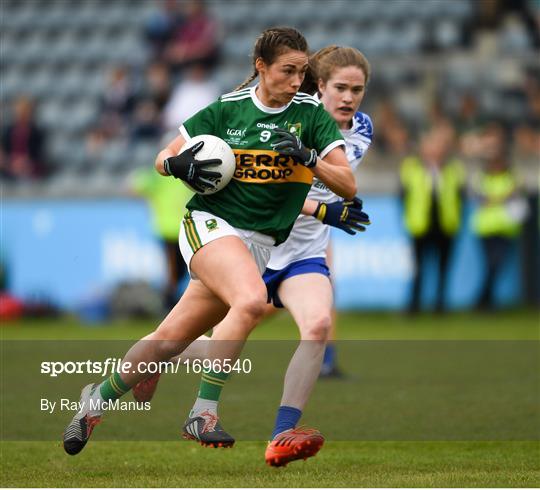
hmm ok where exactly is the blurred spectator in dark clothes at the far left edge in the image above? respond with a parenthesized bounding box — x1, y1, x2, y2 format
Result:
(0, 96, 49, 180)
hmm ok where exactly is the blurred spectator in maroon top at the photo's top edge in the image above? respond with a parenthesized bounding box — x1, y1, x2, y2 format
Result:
(163, 0, 219, 72)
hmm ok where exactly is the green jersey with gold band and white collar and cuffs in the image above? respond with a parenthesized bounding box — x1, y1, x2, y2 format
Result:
(180, 87, 345, 245)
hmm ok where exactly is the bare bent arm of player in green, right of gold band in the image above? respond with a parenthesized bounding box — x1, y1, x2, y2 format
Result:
(313, 147, 356, 199)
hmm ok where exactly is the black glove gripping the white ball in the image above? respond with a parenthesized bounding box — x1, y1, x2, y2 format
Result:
(163, 141, 221, 192)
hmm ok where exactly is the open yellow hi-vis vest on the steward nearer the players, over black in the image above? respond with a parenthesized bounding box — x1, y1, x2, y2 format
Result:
(401, 157, 465, 237)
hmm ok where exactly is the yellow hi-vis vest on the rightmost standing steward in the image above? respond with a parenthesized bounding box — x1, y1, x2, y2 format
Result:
(472, 170, 521, 238)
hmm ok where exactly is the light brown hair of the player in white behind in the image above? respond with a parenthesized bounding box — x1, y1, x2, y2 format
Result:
(300, 45, 371, 94)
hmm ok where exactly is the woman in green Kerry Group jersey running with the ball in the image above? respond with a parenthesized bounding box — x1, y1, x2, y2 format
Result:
(64, 28, 356, 454)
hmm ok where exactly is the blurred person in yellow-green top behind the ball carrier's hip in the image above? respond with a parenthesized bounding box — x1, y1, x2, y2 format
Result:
(132, 168, 193, 310)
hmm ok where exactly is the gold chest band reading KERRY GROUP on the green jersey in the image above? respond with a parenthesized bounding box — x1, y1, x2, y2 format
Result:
(233, 150, 313, 184)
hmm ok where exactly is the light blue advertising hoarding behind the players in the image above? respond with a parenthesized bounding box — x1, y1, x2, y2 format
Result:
(2, 195, 521, 310)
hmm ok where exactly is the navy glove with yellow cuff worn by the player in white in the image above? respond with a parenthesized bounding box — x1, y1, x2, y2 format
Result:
(313, 197, 371, 235)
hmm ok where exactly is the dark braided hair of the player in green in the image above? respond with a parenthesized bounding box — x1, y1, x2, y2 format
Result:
(234, 27, 308, 91)
